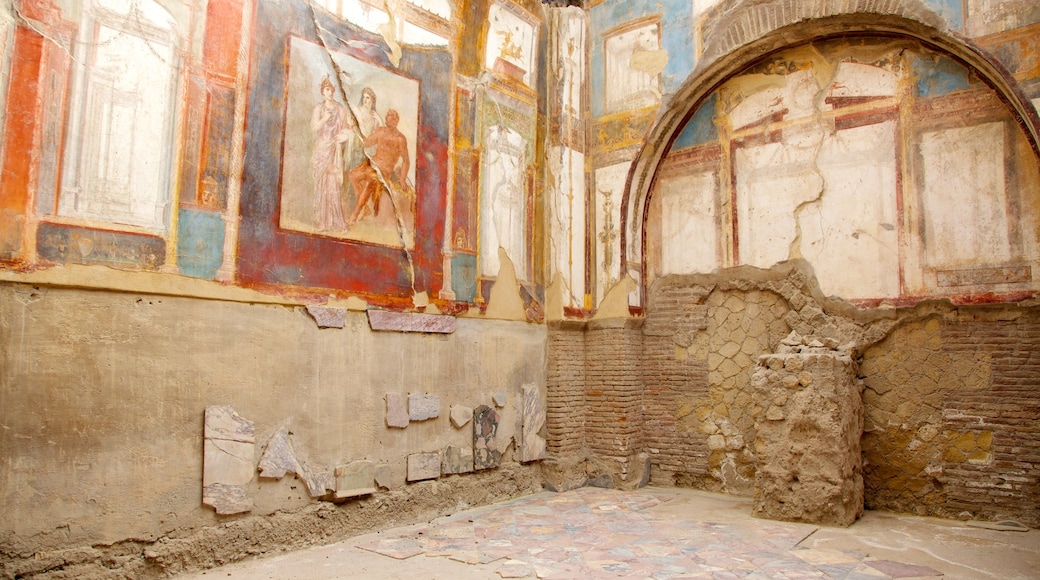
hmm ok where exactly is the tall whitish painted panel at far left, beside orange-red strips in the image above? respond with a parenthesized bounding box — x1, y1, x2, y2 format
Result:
(58, 2, 178, 230)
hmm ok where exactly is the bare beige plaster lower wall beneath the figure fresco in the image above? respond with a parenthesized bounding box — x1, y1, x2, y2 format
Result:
(0, 284, 546, 577)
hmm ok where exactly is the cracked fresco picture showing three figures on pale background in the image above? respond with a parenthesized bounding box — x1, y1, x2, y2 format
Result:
(280, 37, 419, 247)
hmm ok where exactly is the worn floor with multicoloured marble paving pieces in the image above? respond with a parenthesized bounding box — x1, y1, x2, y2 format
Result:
(179, 487, 1040, 580)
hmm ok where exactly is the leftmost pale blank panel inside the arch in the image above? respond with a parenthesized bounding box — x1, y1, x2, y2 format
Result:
(656, 170, 720, 275)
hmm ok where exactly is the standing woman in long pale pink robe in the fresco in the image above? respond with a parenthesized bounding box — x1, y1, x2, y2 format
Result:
(311, 77, 354, 232)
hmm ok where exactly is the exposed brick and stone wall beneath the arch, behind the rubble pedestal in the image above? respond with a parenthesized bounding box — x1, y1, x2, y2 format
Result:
(632, 266, 1040, 526)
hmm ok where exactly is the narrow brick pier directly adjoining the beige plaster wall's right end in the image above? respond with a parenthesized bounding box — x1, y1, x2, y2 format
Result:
(545, 324, 586, 457)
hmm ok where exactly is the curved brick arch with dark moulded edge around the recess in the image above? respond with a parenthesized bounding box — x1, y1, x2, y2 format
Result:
(620, 6, 1040, 306)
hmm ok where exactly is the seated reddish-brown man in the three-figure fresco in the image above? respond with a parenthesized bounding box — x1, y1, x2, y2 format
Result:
(346, 109, 411, 226)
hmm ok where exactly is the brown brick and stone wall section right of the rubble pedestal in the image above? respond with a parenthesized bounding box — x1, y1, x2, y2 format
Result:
(860, 307, 1040, 527)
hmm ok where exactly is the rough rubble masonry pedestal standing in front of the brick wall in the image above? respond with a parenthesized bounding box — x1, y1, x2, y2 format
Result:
(752, 351, 863, 526)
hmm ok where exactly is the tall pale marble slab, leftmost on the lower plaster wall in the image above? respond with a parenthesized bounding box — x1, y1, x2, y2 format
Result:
(202, 405, 256, 515)
